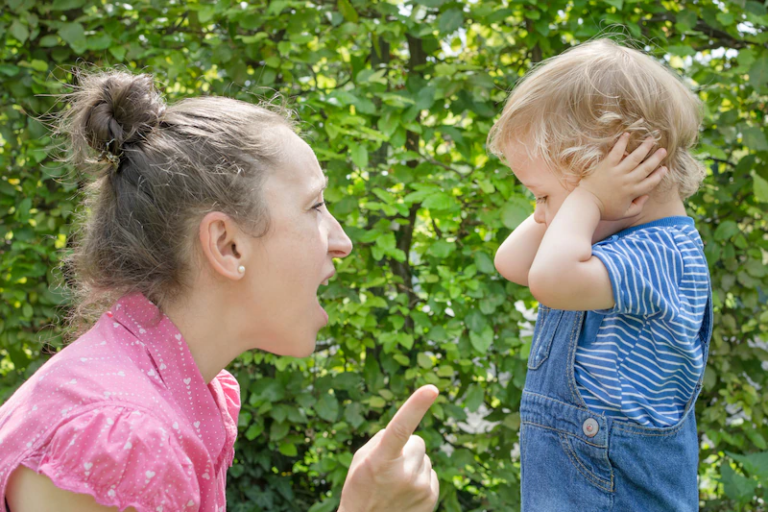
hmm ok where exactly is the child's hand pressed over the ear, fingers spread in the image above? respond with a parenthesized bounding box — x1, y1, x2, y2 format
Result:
(578, 133, 667, 220)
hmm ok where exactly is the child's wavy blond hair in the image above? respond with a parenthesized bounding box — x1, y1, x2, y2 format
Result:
(488, 39, 706, 199)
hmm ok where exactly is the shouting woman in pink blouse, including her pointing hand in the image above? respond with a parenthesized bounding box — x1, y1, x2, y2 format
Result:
(0, 72, 439, 512)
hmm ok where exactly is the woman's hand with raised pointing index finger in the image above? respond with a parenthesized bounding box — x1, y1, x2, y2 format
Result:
(339, 385, 440, 512)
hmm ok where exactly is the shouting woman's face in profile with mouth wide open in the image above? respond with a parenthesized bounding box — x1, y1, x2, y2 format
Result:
(242, 128, 352, 357)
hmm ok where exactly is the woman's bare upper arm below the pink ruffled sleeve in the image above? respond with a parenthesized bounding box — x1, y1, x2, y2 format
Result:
(6, 465, 136, 512)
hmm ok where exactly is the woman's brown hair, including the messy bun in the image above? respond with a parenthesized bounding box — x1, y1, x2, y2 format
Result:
(57, 71, 293, 330)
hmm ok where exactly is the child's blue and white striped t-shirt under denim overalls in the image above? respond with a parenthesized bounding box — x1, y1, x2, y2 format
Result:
(574, 216, 712, 427)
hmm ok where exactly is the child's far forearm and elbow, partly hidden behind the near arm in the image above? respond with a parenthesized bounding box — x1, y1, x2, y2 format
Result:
(493, 211, 547, 286)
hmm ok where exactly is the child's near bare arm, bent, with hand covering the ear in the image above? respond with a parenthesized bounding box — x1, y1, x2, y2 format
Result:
(528, 134, 666, 311)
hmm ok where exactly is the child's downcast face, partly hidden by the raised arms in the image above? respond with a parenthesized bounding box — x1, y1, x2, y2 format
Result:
(503, 143, 578, 226)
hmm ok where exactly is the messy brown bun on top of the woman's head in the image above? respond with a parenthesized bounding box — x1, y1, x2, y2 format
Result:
(60, 70, 165, 171)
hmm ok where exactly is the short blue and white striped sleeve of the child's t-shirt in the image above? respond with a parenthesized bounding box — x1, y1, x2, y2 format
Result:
(592, 231, 686, 320)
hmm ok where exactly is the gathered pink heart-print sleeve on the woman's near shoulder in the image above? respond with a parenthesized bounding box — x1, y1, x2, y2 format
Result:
(24, 407, 200, 512)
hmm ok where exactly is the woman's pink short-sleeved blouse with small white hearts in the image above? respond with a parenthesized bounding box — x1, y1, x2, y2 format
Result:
(0, 294, 240, 512)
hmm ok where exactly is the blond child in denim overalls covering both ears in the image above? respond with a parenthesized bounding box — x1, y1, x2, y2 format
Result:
(489, 40, 712, 512)
